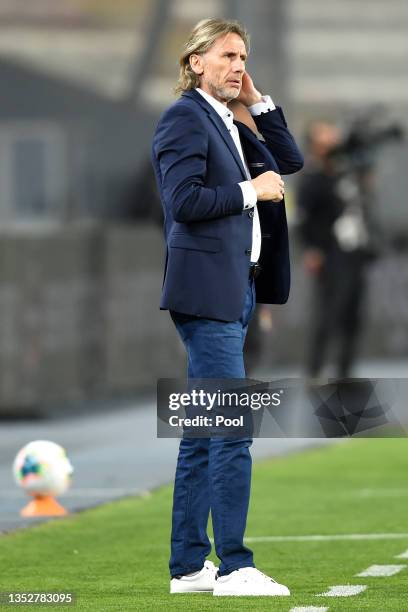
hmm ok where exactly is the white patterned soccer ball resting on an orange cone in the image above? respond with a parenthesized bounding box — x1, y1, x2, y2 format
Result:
(13, 440, 74, 497)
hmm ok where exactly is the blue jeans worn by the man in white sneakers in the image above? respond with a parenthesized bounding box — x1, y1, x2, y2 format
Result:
(169, 280, 255, 577)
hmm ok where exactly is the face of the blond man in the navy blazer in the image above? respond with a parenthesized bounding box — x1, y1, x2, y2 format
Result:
(190, 32, 247, 104)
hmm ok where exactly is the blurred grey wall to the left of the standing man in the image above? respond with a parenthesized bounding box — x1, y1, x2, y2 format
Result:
(0, 224, 184, 415)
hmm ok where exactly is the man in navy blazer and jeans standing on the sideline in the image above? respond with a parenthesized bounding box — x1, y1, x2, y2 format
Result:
(152, 19, 303, 595)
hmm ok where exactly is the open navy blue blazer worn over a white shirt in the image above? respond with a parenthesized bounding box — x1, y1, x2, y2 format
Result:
(152, 90, 303, 321)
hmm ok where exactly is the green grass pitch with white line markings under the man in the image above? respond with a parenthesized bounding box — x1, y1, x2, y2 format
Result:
(0, 439, 408, 612)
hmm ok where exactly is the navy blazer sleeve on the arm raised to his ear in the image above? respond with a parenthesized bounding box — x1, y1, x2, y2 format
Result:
(253, 106, 304, 174)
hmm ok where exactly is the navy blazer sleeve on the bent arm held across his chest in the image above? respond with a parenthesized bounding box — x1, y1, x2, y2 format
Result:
(152, 104, 243, 223)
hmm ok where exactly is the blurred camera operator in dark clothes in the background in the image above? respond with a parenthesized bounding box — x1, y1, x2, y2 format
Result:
(296, 121, 378, 378)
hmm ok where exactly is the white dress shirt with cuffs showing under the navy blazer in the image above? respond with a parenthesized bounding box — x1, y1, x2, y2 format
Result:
(196, 87, 276, 263)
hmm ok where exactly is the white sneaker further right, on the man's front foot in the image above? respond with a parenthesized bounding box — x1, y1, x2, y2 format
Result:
(213, 567, 290, 597)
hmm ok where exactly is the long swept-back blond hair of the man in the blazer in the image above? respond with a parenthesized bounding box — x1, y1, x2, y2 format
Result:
(174, 19, 249, 93)
